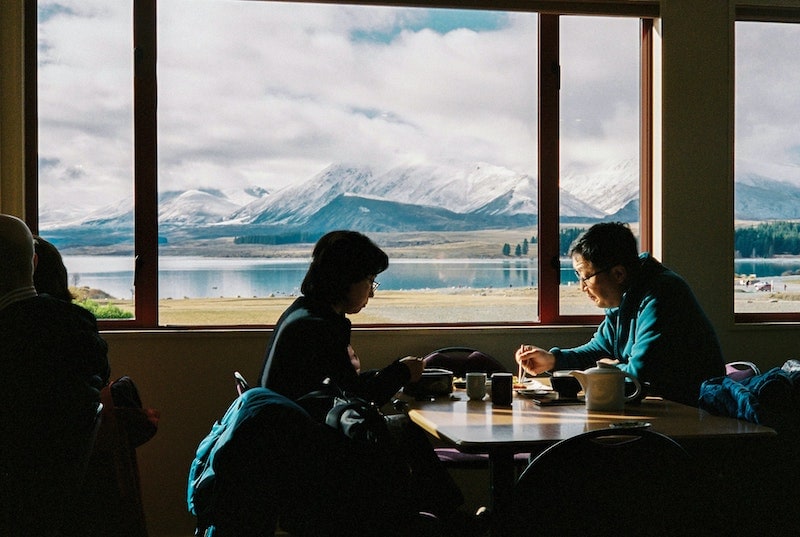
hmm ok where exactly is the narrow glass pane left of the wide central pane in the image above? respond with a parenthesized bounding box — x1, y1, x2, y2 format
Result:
(37, 0, 134, 318)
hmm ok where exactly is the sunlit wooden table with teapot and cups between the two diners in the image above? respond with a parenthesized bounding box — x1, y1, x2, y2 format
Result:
(408, 390, 776, 537)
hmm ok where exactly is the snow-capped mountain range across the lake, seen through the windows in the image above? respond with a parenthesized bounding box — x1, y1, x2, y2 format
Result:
(40, 160, 800, 246)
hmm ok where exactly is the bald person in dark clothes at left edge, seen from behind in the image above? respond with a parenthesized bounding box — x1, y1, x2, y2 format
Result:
(0, 211, 110, 536)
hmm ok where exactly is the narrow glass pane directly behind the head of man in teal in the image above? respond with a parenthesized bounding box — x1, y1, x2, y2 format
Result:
(559, 17, 641, 315)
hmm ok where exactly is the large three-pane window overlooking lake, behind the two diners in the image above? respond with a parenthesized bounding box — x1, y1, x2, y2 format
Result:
(38, 0, 646, 326)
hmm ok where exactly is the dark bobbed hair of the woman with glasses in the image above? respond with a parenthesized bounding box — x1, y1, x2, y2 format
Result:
(300, 230, 389, 304)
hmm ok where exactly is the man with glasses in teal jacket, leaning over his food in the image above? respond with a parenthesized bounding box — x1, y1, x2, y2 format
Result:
(516, 223, 725, 406)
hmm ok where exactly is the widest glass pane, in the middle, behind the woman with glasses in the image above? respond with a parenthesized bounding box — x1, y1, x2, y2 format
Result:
(158, 0, 538, 325)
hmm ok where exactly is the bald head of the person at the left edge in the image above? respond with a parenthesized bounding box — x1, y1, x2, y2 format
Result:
(0, 214, 34, 295)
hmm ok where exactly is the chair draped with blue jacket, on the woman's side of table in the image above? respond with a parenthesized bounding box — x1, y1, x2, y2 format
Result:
(187, 387, 436, 537)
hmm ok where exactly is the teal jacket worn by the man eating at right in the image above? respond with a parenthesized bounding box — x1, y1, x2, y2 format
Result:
(550, 253, 725, 406)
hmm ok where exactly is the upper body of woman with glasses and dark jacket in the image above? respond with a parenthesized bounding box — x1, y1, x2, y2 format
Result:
(261, 231, 424, 405)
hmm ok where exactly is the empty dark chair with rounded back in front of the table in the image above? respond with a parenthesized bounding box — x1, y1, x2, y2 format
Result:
(513, 428, 696, 536)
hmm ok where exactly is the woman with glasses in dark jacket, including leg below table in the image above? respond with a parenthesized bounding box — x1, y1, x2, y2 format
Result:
(260, 231, 476, 535)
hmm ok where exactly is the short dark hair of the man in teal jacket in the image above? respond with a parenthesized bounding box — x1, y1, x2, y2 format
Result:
(569, 222, 639, 270)
